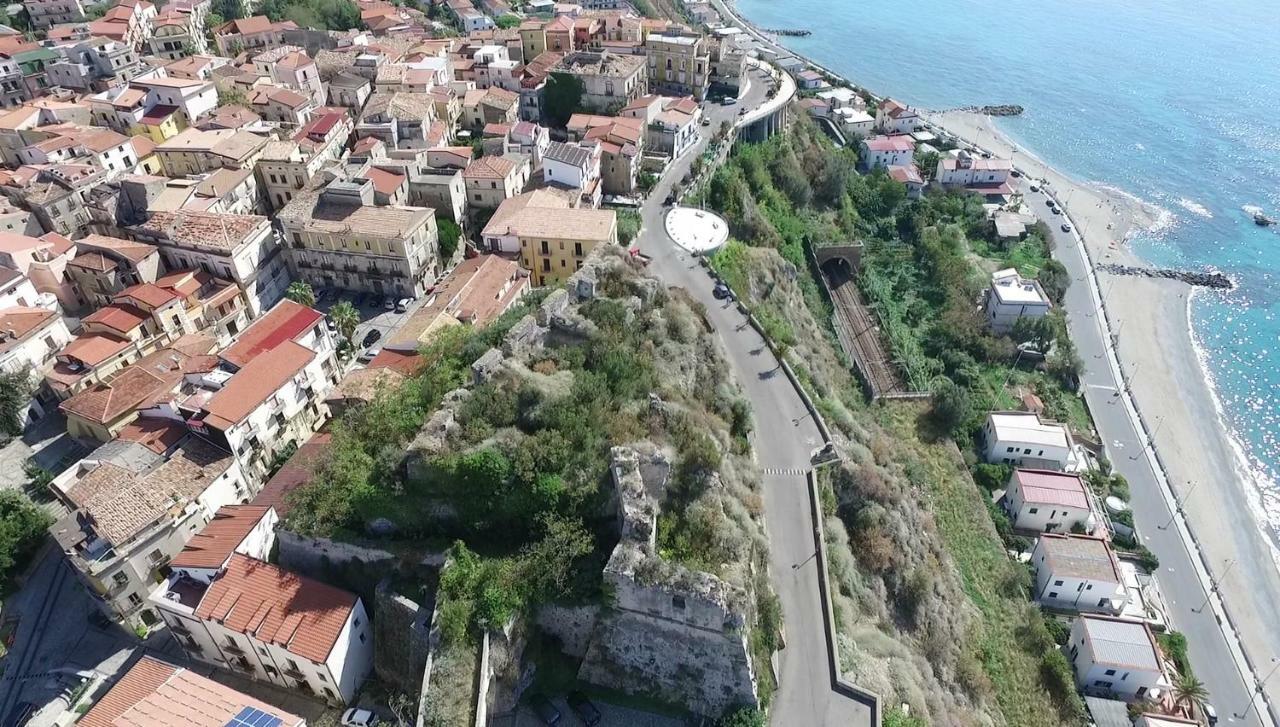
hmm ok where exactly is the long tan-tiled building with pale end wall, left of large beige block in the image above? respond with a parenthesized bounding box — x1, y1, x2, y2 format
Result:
(129, 210, 289, 314)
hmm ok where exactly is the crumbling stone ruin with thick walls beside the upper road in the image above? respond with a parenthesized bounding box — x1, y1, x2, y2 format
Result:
(579, 447, 758, 717)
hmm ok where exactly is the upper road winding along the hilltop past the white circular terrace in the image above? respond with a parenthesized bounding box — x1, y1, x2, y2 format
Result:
(637, 69, 872, 727)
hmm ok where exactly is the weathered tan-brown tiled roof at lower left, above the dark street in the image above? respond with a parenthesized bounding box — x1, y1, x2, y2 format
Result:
(67, 436, 232, 544)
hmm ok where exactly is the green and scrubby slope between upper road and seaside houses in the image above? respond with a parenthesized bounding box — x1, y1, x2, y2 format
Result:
(703, 119, 1083, 727)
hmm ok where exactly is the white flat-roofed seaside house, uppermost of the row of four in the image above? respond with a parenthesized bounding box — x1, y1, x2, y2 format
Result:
(982, 411, 1084, 472)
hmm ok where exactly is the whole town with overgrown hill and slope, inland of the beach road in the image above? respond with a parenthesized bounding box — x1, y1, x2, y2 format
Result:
(0, 0, 1228, 727)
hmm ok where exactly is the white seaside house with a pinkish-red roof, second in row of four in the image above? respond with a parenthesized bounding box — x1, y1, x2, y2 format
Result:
(1005, 470, 1097, 532)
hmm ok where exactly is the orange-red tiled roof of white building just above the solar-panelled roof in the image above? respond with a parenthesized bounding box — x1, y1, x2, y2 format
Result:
(196, 553, 358, 664)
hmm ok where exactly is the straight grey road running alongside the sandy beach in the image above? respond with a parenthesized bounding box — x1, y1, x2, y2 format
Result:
(1034, 179, 1271, 727)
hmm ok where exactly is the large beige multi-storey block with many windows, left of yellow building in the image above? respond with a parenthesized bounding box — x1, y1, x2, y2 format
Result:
(279, 183, 440, 297)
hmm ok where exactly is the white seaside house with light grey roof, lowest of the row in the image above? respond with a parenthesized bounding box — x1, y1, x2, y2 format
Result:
(1068, 616, 1169, 699)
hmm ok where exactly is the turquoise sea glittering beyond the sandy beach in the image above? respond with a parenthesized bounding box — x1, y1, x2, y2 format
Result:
(737, 0, 1280, 504)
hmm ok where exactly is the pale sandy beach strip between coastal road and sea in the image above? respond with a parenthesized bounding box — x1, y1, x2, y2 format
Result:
(713, 0, 1280, 712)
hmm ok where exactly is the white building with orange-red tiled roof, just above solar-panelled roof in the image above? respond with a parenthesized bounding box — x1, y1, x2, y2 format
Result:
(151, 552, 374, 704)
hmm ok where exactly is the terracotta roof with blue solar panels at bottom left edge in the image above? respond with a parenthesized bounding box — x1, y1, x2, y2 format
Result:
(78, 657, 305, 727)
